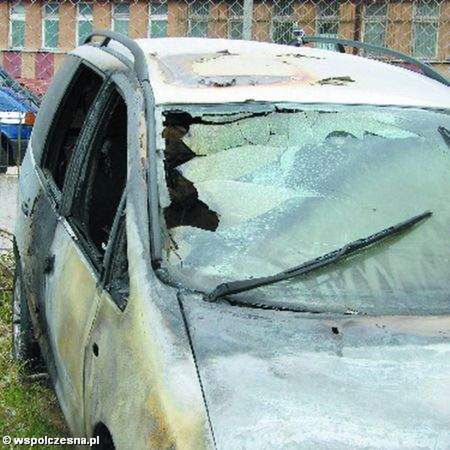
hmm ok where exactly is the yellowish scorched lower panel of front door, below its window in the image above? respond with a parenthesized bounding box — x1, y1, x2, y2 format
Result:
(44, 225, 97, 435)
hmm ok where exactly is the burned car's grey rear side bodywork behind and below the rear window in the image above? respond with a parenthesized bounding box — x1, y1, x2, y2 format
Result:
(15, 56, 80, 352)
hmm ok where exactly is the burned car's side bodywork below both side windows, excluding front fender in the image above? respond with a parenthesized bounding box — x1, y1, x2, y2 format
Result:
(16, 144, 96, 435)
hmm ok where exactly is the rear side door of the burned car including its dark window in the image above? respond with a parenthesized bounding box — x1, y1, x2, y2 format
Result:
(16, 56, 107, 379)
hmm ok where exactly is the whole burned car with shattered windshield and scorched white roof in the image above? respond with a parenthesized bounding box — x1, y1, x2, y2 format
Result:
(14, 32, 450, 450)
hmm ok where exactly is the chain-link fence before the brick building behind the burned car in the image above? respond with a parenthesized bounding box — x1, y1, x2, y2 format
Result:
(0, 0, 450, 96)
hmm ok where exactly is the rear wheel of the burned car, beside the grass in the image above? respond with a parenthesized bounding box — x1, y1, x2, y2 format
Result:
(12, 269, 40, 370)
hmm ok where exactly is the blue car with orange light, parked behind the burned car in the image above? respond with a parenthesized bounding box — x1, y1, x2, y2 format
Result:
(0, 68, 39, 173)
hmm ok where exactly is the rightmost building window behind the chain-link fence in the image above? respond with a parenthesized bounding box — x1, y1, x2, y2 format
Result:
(413, 0, 440, 59)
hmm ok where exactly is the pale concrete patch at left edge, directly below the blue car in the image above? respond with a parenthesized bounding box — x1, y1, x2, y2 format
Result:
(0, 174, 18, 251)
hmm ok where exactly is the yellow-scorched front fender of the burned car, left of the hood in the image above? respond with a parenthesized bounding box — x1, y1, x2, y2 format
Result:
(85, 229, 214, 450)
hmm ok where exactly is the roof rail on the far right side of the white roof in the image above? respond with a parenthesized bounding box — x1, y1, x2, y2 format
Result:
(290, 30, 450, 86)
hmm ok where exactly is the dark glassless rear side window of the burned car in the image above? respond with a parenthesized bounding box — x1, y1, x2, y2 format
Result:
(43, 64, 103, 190)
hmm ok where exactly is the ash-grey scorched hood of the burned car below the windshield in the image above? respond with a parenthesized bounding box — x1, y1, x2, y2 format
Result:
(181, 296, 450, 449)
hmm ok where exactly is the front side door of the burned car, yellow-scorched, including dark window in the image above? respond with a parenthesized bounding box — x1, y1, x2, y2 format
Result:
(45, 77, 132, 434)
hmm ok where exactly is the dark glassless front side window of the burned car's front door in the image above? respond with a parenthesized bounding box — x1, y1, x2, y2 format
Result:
(69, 88, 127, 268)
